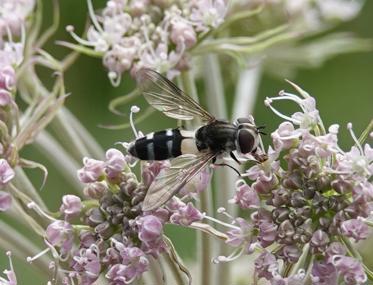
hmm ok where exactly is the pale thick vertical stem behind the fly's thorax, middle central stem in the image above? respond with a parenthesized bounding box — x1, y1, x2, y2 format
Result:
(203, 55, 231, 285)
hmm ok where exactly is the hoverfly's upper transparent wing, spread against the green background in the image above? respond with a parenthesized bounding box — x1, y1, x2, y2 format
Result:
(136, 68, 215, 122)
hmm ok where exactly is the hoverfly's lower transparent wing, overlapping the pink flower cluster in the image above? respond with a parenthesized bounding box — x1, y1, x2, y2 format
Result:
(142, 153, 215, 211)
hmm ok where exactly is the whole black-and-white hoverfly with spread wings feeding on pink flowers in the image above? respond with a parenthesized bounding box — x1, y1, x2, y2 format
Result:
(128, 68, 266, 211)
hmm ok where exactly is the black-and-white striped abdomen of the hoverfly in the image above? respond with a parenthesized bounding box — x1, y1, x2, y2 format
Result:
(128, 129, 198, 160)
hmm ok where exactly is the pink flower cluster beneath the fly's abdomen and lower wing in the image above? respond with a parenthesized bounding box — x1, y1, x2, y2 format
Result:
(29, 149, 203, 284)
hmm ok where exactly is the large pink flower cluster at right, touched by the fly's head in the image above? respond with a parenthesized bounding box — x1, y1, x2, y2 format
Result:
(227, 86, 373, 285)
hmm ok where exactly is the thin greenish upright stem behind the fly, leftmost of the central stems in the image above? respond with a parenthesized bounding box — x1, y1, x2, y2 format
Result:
(181, 72, 215, 285)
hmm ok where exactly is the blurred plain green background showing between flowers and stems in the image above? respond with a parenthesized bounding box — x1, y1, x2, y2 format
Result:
(0, 0, 373, 285)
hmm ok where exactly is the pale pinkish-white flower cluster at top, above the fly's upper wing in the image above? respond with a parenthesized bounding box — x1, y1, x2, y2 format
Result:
(67, 0, 227, 84)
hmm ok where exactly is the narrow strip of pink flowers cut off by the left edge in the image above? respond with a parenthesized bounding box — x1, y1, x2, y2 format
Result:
(0, 0, 35, 211)
